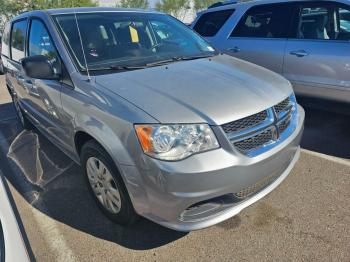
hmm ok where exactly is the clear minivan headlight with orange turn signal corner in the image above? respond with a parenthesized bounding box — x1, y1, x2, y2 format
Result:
(135, 124, 219, 161)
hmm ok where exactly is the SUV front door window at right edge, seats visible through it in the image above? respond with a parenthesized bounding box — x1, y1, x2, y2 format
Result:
(296, 3, 350, 40)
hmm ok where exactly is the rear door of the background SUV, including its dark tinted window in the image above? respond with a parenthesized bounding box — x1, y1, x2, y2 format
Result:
(221, 3, 293, 74)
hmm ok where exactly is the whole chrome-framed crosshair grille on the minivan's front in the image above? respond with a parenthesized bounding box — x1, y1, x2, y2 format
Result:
(222, 95, 297, 157)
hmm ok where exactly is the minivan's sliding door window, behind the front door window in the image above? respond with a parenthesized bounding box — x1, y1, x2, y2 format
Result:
(11, 20, 28, 62)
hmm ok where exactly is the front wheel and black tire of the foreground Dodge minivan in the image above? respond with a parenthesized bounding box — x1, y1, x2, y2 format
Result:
(80, 140, 138, 225)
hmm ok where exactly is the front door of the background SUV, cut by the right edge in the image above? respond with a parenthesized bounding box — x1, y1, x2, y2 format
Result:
(283, 1, 350, 102)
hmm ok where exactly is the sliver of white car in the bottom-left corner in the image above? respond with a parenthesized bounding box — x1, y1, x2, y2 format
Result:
(0, 171, 30, 262)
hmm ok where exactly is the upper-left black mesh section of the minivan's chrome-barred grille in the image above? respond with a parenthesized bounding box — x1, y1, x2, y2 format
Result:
(222, 110, 267, 134)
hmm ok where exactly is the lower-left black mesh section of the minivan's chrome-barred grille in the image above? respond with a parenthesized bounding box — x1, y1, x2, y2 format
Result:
(234, 129, 274, 154)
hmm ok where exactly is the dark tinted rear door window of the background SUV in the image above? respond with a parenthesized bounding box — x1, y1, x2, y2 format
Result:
(231, 4, 293, 38)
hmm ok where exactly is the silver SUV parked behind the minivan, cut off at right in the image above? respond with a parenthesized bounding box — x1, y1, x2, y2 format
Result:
(192, 0, 350, 102)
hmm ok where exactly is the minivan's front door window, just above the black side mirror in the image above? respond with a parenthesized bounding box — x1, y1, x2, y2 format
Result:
(28, 19, 60, 73)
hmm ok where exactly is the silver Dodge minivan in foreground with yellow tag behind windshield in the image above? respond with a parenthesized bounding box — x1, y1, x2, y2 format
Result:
(2, 8, 304, 231)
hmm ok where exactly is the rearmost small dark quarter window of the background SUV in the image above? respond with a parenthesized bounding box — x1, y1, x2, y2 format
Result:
(193, 9, 234, 37)
